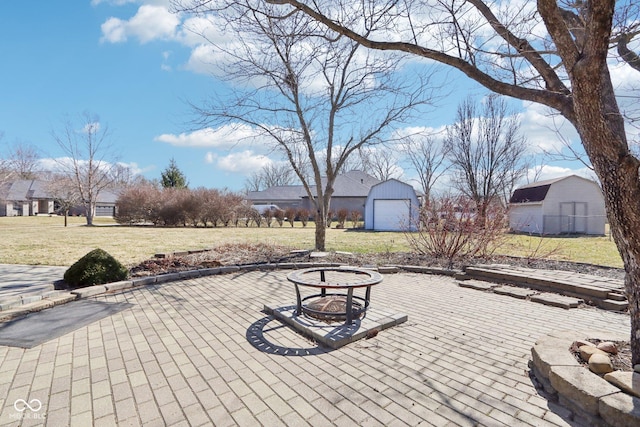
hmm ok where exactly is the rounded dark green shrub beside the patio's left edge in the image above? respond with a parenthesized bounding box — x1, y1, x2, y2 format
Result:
(64, 249, 129, 288)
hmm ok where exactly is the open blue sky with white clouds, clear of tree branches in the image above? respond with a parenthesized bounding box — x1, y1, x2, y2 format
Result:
(0, 0, 637, 190)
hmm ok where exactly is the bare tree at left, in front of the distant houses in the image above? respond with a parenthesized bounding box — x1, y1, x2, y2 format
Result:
(52, 113, 116, 225)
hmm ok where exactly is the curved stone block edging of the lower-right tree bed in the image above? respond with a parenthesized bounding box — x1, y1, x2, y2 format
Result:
(530, 331, 640, 427)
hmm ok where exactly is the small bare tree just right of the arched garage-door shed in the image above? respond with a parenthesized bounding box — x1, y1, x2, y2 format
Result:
(402, 133, 450, 204)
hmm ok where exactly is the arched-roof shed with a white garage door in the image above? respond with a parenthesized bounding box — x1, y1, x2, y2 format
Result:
(364, 179, 420, 231)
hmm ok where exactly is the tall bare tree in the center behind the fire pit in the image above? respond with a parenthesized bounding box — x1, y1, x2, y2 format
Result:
(176, 0, 436, 250)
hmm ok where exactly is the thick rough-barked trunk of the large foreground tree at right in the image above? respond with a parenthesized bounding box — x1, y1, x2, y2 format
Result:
(572, 62, 640, 365)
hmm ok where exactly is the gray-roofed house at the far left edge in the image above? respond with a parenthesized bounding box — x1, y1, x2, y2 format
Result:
(0, 179, 54, 216)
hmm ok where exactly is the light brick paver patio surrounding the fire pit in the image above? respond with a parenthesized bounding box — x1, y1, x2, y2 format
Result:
(0, 271, 630, 426)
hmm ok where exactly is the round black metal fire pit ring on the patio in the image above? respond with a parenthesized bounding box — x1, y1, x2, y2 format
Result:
(287, 267, 382, 325)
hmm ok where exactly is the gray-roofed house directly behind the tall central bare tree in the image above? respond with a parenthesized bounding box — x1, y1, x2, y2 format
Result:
(247, 170, 380, 216)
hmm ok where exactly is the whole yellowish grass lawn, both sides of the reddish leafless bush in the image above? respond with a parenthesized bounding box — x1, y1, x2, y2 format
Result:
(0, 216, 622, 267)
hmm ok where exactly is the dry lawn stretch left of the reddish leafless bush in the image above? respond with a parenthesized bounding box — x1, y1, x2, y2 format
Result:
(0, 216, 408, 266)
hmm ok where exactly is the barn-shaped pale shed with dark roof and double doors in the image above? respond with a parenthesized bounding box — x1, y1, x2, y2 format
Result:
(509, 175, 606, 235)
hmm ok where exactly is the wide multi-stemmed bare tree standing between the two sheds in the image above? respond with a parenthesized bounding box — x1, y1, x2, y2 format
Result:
(445, 95, 527, 218)
